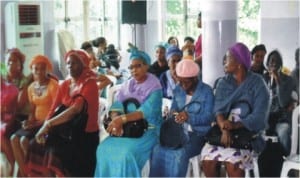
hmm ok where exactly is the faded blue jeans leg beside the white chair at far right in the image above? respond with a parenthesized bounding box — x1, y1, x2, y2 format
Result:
(275, 122, 292, 155)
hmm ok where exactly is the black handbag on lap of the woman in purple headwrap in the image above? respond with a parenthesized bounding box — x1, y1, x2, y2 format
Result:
(205, 100, 258, 150)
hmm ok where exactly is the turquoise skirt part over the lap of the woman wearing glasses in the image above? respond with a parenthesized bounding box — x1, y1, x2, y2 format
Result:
(95, 131, 158, 176)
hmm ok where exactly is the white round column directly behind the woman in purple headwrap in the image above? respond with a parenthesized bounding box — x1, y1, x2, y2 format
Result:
(202, 1, 237, 86)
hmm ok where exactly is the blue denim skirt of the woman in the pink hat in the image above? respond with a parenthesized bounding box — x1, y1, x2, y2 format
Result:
(149, 132, 204, 177)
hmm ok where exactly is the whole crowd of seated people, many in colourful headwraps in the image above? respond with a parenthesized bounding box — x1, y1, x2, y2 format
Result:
(1, 33, 299, 177)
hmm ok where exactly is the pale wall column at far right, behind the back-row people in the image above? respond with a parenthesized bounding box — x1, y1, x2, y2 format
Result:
(259, 0, 300, 70)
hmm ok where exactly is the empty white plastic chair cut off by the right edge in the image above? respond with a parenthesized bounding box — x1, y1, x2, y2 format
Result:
(280, 105, 300, 177)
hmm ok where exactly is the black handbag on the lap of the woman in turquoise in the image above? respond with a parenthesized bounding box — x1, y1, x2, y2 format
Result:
(103, 98, 148, 138)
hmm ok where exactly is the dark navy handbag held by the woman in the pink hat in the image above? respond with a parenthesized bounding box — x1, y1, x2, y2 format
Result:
(159, 101, 200, 149)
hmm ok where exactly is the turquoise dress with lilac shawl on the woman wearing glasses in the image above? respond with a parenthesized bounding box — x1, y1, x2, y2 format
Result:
(95, 74, 162, 177)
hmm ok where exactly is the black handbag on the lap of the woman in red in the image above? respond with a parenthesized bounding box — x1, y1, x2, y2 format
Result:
(47, 95, 88, 142)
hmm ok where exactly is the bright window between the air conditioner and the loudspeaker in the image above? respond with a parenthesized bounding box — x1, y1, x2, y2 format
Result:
(55, 0, 120, 47)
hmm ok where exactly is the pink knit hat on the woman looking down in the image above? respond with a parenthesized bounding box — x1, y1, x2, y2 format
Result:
(176, 60, 200, 78)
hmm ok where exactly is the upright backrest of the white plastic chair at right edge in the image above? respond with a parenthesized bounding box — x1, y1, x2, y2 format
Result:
(290, 105, 300, 155)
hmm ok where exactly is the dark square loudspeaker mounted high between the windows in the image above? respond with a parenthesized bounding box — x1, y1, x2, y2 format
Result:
(122, 0, 147, 24)
